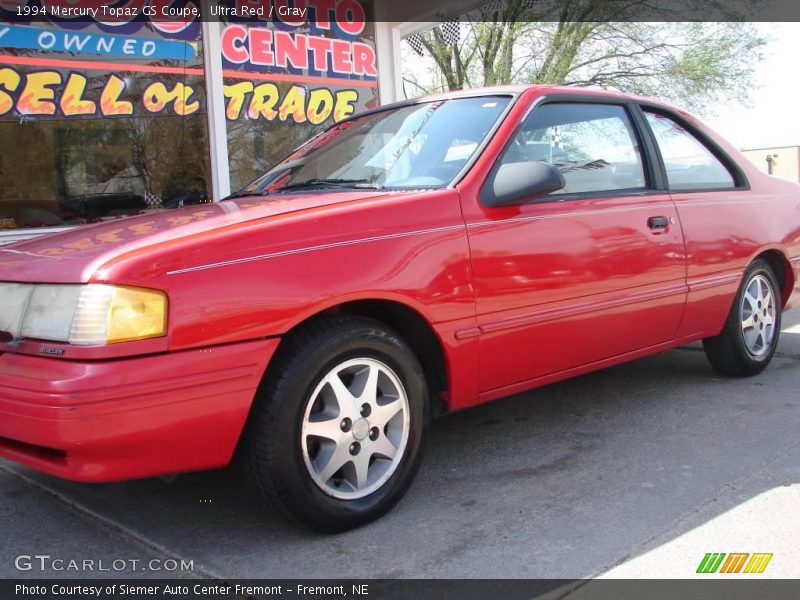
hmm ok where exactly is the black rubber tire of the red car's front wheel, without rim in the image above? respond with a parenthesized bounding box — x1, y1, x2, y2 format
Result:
(240, 315, 428, 533)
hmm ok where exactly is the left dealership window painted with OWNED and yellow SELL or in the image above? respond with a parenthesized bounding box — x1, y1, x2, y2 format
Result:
(0, 15, 210, 230)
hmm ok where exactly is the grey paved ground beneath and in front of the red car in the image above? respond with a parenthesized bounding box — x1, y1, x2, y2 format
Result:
(0, 311, 800, 578)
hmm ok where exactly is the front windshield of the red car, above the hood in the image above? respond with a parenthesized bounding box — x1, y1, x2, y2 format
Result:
(236, 96, 511, 195)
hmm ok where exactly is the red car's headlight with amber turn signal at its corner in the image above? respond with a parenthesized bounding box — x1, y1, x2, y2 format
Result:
(0, 283, 167, 346)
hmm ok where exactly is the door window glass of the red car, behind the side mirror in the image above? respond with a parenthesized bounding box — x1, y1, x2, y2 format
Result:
(502, 102, 647, 195)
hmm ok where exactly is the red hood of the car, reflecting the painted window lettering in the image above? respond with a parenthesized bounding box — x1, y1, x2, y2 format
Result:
(0, 191, 389, 283)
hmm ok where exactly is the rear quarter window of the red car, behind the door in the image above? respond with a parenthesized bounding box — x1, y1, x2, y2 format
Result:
(645, 112, 736, 190)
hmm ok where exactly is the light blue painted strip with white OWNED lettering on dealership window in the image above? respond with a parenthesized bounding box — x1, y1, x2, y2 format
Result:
(0, 25, 195, 60)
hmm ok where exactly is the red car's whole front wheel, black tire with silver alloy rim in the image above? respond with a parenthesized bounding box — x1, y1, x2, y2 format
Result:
(241, 316, 428, 532)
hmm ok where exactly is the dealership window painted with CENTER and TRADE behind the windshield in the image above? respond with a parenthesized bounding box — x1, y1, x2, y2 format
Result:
(220, 9, 378, 191)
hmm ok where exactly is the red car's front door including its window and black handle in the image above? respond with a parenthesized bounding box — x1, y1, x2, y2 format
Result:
(462, 96, 686, 394)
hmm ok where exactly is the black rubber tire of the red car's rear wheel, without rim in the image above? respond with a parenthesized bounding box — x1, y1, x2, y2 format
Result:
(703, 258, 783, 377)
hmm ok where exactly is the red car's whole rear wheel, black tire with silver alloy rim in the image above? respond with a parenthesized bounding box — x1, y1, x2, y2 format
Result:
(703, 259, 782, 376)
